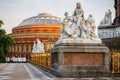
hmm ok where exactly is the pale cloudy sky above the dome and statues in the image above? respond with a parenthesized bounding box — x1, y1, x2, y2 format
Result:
(0, 0, 115, 33)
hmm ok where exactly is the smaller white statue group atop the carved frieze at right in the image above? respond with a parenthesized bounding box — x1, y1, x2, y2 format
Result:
(99, 9, 112, 26)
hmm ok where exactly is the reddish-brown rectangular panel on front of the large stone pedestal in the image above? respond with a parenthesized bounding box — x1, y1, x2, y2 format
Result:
(64, 53, 103, 65)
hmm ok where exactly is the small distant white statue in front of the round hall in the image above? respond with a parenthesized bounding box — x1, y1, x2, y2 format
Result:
(32, 39, 45, 53)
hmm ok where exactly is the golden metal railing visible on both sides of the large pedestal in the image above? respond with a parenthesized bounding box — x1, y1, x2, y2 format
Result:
(31, 51, 120, 74)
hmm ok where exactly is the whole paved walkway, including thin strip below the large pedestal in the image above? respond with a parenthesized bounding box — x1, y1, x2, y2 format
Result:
(0, 63, 120, 80)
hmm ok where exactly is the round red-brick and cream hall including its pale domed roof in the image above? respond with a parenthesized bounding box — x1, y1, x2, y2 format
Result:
(6, 13, 61, 60)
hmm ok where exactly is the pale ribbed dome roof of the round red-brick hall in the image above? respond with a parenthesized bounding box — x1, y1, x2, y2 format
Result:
(18, 13, 61, 26)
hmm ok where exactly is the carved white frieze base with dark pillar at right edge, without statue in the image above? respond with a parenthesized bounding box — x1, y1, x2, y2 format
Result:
(98, 0, 120, 50)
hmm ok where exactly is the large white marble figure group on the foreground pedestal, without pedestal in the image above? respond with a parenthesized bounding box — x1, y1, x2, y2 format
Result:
(57, 2, 101, 44)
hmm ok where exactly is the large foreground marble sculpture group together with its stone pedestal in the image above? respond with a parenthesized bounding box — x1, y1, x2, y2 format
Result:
(50, 2, 110, 77)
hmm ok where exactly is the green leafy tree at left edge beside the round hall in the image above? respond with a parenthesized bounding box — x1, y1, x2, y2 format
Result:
(0, 20, 13, 62)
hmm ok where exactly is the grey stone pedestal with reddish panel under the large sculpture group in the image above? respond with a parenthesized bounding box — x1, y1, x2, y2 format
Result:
(50, 43, 110, 77)
